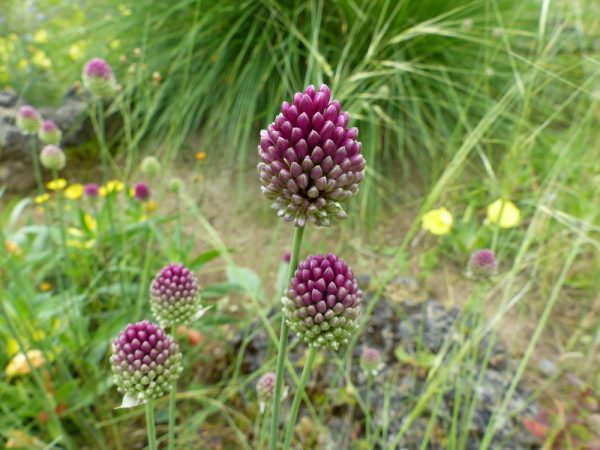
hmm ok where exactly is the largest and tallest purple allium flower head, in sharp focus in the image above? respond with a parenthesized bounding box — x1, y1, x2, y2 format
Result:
(258, 85, 365, 226)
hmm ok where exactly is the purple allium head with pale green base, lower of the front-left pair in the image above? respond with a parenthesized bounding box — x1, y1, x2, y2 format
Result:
(110, 320, 182, 404)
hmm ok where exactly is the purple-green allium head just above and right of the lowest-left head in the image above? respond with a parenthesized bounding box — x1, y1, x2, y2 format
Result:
(150, 263, 202, 326)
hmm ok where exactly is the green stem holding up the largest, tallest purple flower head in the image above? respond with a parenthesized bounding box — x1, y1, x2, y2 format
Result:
(269, 227, 304, 450)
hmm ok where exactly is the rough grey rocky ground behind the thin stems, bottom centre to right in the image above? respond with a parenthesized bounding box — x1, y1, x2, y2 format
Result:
(236, 279, 539, 450)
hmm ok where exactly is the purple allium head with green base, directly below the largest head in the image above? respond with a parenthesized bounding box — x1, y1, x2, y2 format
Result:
(281, 253, 362, 350)
